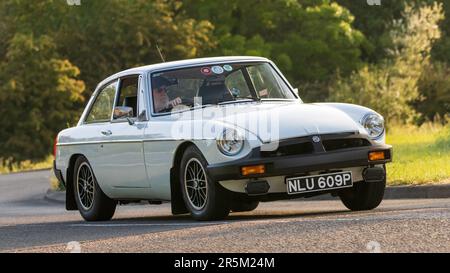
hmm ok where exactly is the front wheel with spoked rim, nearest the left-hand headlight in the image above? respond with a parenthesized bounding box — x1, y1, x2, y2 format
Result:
(179, 146, 230, 221)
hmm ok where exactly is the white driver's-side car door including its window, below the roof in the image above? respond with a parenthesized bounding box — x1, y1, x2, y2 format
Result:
(101, 75, 150, 191)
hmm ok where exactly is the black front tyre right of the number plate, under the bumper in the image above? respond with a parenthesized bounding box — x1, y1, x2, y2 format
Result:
(339, 177, 386, 211)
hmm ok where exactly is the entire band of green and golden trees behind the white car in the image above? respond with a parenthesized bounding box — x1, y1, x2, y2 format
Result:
(0, 0, 450, 162)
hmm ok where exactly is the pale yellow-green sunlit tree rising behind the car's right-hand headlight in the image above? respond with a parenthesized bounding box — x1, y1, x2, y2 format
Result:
(330, 3, 444, 122)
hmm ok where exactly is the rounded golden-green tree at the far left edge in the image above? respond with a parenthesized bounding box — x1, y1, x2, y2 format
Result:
(0, 34, 84, 163)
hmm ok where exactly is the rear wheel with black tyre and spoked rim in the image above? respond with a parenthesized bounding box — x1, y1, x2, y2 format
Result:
(73, 156, 117, 221)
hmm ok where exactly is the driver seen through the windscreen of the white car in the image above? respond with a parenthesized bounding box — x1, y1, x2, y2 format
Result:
(152, 76, 182, 113)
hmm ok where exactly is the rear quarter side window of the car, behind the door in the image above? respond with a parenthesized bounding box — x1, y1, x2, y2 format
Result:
(86, 82, 116, 123)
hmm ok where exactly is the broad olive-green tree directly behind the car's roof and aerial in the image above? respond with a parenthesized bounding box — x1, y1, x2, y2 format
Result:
(55, 0, 213, 93)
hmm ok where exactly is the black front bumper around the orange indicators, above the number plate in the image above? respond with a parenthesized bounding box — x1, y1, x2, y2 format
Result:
(207, 141, 392, 181)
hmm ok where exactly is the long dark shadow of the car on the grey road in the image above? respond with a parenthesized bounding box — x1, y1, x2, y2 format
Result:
(0, 206, 390, 252)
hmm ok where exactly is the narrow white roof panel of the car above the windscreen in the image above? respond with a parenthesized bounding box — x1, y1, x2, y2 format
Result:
(98, 56, 269, 86)
